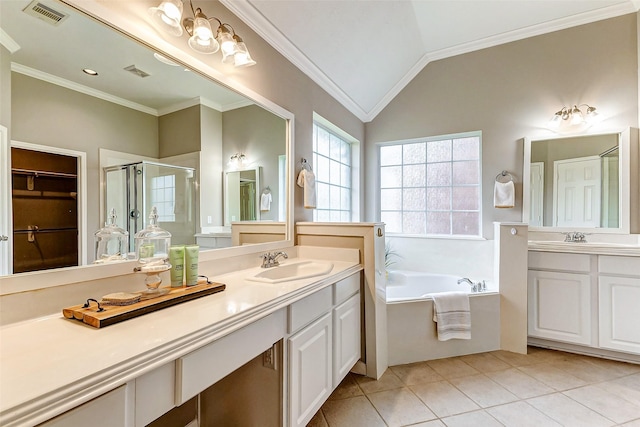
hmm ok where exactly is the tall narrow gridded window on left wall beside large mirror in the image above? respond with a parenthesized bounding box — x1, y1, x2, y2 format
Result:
(313, 116, 353, 222)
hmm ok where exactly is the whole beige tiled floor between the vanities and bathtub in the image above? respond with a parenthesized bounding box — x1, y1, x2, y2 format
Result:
(308, 347, 640, 427)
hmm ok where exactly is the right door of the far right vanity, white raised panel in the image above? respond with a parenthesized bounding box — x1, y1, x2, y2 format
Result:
(598, 276, 640, 354)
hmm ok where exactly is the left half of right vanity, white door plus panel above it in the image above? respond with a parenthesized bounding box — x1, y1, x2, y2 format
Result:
(527, 252, 594, 345)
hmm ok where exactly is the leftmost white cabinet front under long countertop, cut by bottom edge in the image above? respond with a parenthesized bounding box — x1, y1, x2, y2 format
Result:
(40, 385, 127, 427)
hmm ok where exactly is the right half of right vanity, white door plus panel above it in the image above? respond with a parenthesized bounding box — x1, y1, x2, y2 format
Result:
(598, 256, 640, 354)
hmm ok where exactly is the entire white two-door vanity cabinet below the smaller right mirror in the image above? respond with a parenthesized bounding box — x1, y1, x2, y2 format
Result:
(528, 246, 640, 362)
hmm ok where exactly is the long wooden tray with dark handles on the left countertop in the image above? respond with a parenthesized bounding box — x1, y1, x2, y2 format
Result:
(62, 283, 226, 328)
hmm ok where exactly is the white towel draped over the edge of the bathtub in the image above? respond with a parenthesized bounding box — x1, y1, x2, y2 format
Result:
(430, 292, 471, 341)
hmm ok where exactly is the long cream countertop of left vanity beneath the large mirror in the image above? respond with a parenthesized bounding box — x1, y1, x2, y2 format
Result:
(0, 258, 362, 424)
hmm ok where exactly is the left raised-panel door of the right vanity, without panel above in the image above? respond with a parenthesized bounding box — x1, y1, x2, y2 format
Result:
(528, 270, 592, 345)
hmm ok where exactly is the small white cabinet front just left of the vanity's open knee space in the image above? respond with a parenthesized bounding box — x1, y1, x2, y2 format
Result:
(135, 362, 176, 427)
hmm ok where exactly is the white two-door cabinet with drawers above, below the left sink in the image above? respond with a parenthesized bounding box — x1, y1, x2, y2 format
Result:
(287, 273, 361, 426)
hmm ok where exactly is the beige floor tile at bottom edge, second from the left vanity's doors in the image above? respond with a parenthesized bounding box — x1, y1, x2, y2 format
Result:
(367, 388, 437, 427)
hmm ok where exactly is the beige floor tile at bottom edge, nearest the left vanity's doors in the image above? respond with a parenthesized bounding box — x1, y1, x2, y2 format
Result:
(322, 396, 385, 427)
